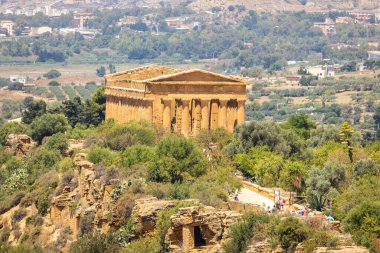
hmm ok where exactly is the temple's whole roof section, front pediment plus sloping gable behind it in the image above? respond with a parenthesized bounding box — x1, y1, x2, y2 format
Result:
(106, 65, 243, 83)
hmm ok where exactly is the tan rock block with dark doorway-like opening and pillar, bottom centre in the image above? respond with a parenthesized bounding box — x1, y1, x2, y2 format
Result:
(166, 206, 242, 252)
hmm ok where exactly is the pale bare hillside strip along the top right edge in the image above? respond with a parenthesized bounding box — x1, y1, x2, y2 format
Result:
(191, 0, 379, 12)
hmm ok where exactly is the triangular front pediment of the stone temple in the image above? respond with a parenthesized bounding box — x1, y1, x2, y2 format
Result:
(145, 69, 242, 83)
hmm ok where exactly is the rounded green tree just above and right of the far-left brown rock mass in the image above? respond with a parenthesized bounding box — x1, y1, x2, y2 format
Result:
(31, 114, 69, 143)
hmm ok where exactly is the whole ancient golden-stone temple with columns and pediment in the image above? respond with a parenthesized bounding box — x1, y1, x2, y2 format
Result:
(105, 65, 246, 136)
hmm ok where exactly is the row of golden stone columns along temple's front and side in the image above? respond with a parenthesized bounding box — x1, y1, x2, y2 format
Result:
(107, 96, 245, 136)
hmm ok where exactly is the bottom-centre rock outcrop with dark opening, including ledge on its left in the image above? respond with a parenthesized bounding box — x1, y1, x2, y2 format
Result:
(132, 197, 242, 252)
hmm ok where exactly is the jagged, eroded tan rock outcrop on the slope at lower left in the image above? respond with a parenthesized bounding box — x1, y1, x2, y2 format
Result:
(50, 153, 118, 236)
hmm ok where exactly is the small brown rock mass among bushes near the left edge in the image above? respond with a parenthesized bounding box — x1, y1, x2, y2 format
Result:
(6, 134, 36, 157)
